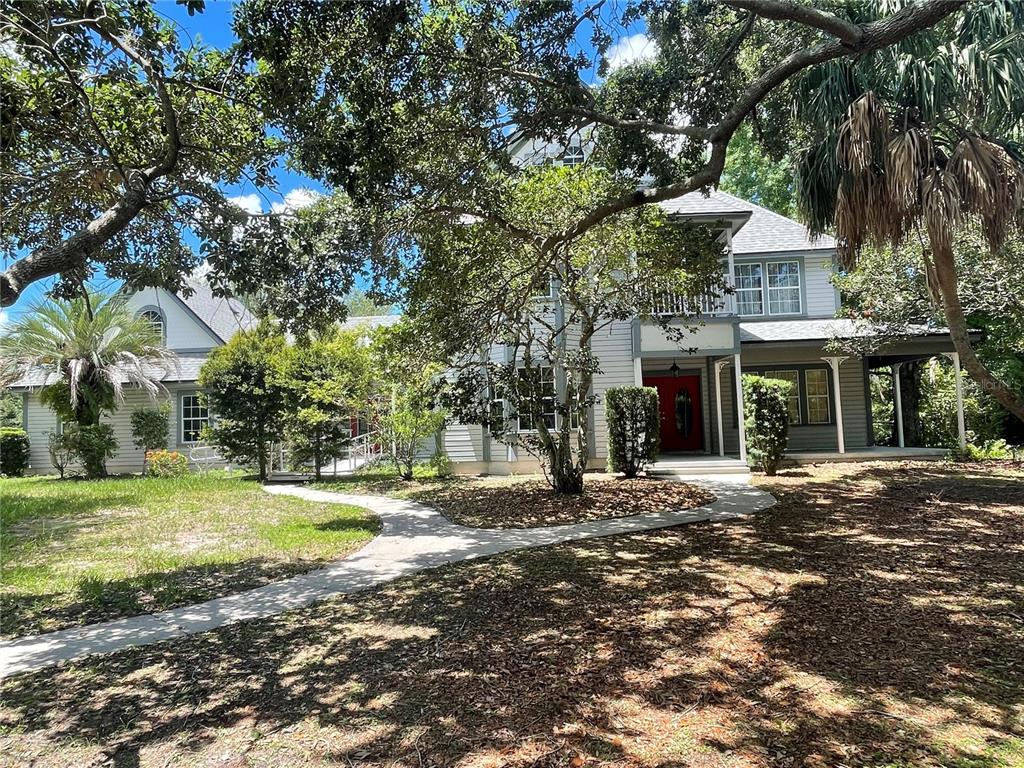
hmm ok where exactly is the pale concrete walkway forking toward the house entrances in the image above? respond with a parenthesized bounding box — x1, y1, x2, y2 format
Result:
(0, 475, 775, 678)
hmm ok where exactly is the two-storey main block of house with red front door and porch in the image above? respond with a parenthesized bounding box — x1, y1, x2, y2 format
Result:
(443, 187, 966, 474)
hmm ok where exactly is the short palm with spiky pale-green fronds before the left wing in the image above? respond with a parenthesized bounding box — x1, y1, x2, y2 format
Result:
(0, 293, 177, 426)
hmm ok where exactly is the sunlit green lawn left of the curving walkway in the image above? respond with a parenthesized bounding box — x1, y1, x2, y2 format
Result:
(0, 473, 378, 637)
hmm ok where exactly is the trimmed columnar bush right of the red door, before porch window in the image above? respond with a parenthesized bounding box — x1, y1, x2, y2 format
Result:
(743, 374, 793, 475)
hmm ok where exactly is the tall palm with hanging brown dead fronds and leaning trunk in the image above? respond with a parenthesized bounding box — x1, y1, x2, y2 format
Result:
(796, 0, 1024, 421)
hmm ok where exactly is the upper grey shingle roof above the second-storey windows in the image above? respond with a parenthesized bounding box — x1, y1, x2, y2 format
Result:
(662, 189, 836, 254)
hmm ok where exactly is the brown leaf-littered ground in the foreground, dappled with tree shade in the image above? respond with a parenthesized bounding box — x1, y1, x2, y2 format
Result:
(0, 464, 1024, 768)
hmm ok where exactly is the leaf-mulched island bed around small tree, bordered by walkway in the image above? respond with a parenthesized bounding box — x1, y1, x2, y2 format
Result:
(412, 475, 715, 528)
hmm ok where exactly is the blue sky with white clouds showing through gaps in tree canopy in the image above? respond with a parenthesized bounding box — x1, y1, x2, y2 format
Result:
(0, 0, 656, 328)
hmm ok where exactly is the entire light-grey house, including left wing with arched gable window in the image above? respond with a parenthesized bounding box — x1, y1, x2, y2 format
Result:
(13, 167, 966, 474)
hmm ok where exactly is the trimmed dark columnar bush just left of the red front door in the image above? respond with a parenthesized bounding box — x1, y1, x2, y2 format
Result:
(604, 387, 662, 477)
